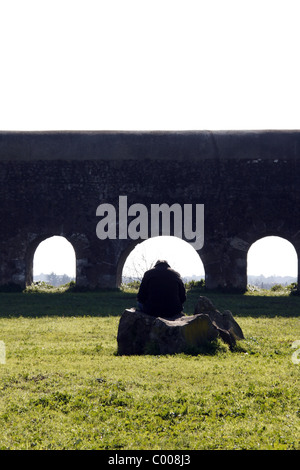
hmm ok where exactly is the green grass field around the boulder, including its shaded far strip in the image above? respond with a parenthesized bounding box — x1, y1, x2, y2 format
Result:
(0, 290, 300, 450)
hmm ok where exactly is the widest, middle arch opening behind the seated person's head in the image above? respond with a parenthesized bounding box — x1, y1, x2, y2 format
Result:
(122, 235, 205, 284)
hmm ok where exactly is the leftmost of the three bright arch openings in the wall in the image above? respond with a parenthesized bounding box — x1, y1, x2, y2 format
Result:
(33, 236, 76, 286)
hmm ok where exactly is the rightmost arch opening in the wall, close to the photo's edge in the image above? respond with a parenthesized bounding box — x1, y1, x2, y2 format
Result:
(247, 236, 298, 289)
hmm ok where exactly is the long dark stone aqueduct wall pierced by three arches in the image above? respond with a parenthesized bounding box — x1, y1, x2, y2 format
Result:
(0, 131, 300, 291)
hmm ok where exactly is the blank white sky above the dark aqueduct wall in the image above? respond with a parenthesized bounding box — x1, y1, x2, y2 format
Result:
(0, 0, 300, 280)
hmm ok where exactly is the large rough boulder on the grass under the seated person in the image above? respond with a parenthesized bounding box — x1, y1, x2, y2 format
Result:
(117, 297, 244, 355)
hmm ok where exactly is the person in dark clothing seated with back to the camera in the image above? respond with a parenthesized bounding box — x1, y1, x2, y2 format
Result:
(137, 260, 186, 318)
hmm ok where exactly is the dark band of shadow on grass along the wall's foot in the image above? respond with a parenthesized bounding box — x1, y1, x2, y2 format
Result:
(0, 289, 300, 318)
